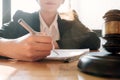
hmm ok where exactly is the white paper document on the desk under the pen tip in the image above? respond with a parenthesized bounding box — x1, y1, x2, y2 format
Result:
(46, 49, 89, 62)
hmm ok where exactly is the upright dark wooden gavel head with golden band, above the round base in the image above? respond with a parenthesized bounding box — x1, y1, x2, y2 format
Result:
(103, 9, 120, 53)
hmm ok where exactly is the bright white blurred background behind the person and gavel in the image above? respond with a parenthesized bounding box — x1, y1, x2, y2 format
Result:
(0, 0, 120, 35)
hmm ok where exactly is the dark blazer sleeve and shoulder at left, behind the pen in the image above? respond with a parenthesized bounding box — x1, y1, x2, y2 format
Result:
(0, 11, 30, 39)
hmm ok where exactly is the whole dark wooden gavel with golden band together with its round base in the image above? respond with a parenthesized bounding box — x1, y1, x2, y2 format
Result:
(78, 9, 120, 78)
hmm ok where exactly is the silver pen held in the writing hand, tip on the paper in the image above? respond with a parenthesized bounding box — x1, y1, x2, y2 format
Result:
(18, 19, 59, 55)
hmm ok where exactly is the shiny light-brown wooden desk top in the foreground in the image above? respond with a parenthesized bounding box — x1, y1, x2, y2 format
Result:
(0, 59, 116, 80)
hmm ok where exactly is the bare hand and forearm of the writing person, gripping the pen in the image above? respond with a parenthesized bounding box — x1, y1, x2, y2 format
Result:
(0, 34, 53, 61)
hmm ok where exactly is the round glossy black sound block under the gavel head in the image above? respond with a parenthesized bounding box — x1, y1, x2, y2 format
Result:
(77, 52, 120, 77)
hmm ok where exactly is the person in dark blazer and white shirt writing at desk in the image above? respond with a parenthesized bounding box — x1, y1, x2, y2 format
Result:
(0, 0, 100, 61)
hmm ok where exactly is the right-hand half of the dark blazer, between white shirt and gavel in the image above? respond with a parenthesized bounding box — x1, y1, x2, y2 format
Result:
(58, 16, 100, 50)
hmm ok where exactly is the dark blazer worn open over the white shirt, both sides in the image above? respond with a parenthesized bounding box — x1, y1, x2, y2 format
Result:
(0, 11, 100, 50)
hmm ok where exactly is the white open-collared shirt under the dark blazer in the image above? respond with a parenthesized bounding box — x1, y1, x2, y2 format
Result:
(39, 13, 60, 41)
